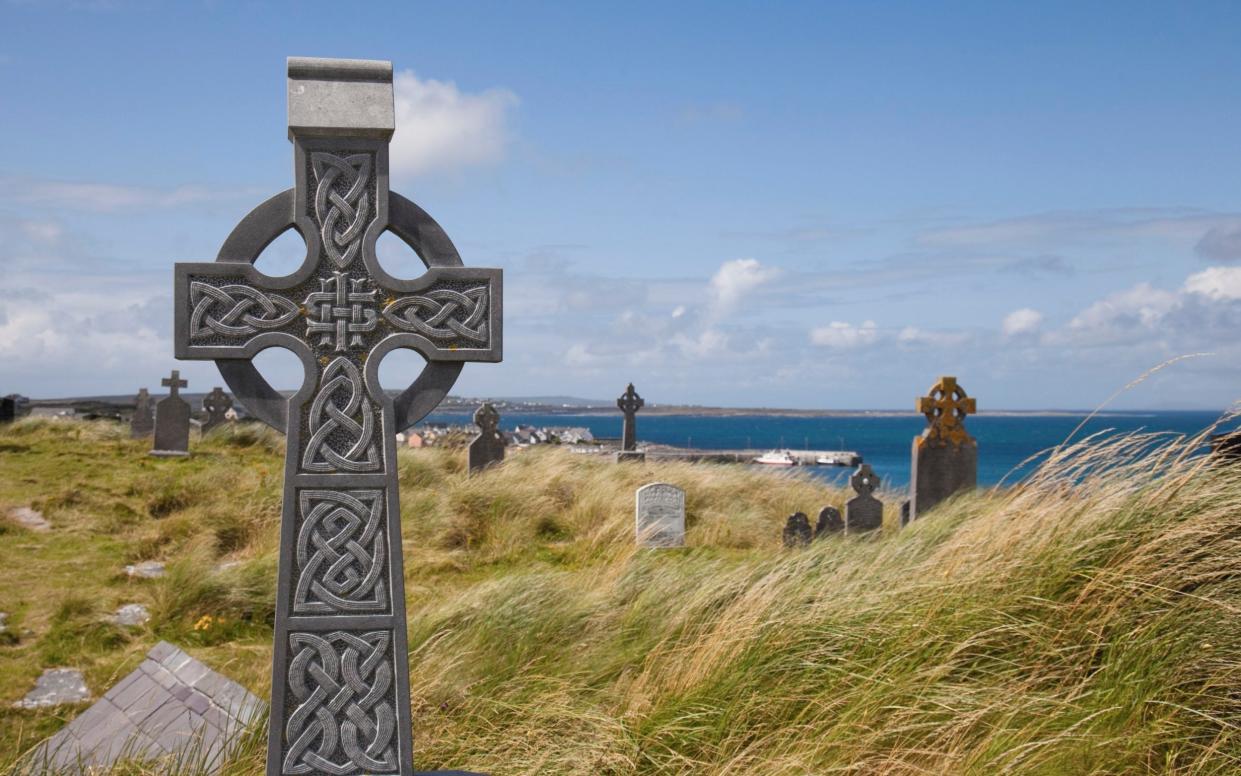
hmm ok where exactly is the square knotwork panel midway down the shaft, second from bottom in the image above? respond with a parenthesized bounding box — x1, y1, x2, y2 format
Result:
(293, 490, 388, 613)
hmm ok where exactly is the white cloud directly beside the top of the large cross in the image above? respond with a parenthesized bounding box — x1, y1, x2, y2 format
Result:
(390, 71, 520, 175)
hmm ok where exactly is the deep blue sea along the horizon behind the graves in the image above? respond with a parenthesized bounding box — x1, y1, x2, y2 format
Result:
(427, 411, 1236, 488)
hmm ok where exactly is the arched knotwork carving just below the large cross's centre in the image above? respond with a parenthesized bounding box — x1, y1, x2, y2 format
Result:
(302, 356, 380, 472)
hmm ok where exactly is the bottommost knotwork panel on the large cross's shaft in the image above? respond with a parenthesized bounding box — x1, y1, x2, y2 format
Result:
(283, 631, 398, 776)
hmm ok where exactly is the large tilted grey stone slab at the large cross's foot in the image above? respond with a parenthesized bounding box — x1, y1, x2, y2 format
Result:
(24, 642, 266, 774)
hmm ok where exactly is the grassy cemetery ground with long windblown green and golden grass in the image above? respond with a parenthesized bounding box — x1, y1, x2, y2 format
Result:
(0, 420, 1241, 776)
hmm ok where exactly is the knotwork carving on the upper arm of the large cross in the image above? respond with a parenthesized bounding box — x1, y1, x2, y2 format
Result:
(310, 151, 371, 269)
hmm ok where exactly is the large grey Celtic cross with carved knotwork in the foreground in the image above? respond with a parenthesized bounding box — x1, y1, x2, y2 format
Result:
(175, 58, 501, 776)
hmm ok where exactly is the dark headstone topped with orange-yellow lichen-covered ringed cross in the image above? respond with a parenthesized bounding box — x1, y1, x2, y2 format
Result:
(910, 376, 978, 520)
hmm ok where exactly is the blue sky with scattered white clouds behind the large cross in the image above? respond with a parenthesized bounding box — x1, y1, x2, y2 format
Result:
(0, 0, 1241, 408)
